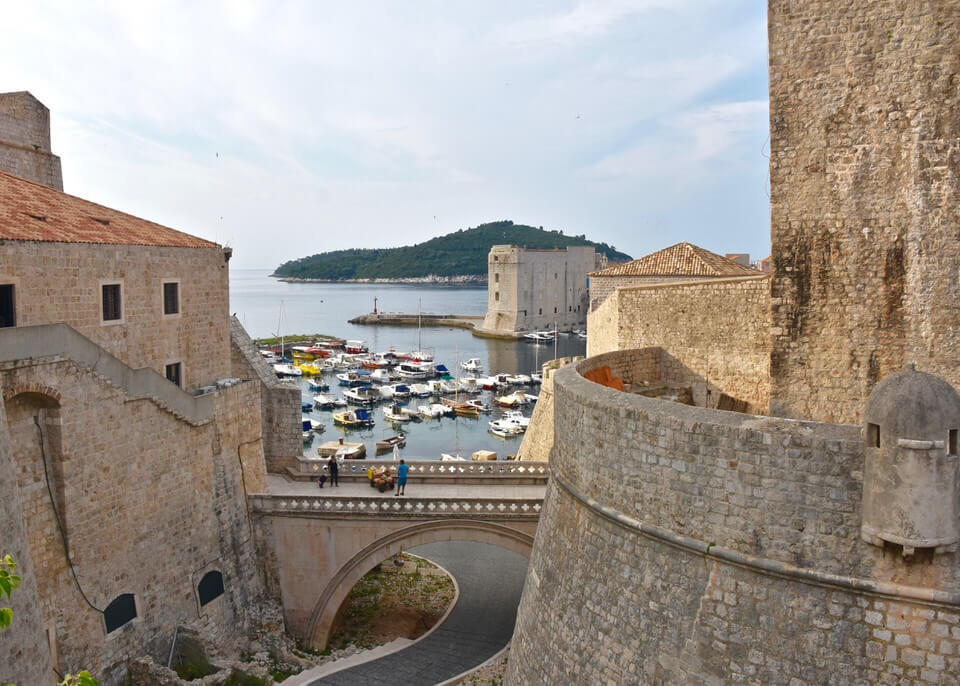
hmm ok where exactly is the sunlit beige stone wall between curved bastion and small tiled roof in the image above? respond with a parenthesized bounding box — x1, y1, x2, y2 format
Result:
(587, 276, 770, 413)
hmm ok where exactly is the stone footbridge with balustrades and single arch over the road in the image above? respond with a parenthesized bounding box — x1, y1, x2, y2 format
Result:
(249, 460, 549, 648)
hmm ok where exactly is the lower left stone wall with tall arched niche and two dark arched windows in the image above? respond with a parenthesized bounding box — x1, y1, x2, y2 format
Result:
(0, 359, 265, 685)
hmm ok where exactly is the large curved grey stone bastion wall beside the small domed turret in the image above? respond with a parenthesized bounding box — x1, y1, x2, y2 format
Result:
(507, 350, 960, 684)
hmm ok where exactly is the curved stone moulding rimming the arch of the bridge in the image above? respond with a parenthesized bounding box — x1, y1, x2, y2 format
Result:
(306, 519, 533, 649)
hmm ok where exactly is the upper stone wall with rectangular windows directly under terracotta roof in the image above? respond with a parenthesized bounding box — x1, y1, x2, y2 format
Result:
(0, 241, 230, 389)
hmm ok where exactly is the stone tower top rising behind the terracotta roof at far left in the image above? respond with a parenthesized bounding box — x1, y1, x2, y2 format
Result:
(0, 91, 63, 191)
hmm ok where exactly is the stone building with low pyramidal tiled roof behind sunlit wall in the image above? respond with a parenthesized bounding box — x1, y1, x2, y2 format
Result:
(588, 241, 757, 319)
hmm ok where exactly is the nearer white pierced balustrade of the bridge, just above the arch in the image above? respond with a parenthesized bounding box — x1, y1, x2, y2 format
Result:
(250, 495, 543, 519)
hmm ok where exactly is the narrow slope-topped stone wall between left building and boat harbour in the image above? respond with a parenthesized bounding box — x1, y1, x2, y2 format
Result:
(230, 317, 303, 472)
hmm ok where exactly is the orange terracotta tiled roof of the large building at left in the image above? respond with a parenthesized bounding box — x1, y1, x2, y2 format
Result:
(0, 172, 219, 248)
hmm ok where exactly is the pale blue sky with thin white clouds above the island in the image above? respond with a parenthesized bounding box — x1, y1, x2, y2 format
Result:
(0, 0, 770, 268)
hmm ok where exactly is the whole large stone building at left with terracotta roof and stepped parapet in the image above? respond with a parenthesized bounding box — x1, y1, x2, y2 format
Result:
(0, 161, 300, 685)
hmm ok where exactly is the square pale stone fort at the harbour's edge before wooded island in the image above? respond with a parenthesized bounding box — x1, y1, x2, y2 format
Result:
(476, 245, 606, 336)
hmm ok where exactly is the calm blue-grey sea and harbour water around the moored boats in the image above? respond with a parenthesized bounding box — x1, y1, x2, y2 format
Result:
(230, 269, 586, 460)
